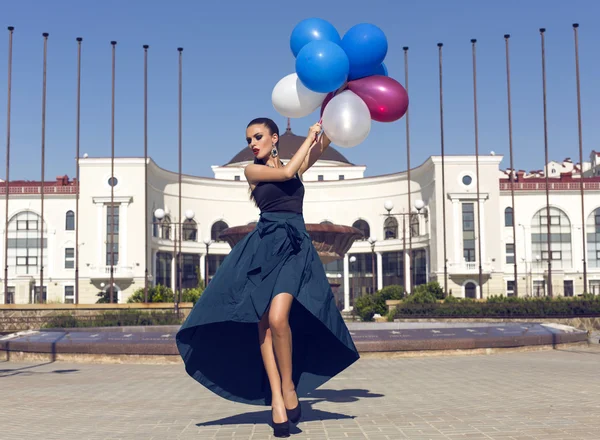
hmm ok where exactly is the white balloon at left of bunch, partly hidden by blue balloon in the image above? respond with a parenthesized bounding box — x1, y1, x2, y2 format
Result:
(271, 73, 327, 118)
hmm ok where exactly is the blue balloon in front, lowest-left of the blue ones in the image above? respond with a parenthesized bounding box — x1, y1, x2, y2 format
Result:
(296, 40, 350, 93)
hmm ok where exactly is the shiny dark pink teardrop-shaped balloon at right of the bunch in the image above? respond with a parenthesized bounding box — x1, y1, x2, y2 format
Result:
(348, 75, 408, 122)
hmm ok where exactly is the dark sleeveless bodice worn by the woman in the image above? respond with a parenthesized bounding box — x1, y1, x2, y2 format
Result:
(252, 175, 304, 214)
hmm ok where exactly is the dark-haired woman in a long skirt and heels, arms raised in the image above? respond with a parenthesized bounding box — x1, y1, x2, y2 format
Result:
(176, 118, 359, 437)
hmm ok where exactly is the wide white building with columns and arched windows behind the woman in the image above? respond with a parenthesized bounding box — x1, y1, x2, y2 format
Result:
(0, 124, 600, 309)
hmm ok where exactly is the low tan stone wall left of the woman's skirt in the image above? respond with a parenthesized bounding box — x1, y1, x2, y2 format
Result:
(0, 303, 193, 333)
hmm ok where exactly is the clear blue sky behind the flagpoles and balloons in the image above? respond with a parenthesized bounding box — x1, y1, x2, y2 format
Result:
(0, 0, 600, 180)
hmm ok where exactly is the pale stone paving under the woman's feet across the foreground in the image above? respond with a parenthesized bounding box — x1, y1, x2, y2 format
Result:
(0, 343, 600, 440)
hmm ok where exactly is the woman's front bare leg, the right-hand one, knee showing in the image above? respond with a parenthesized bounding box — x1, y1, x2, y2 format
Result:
(269, 293, 298, 409)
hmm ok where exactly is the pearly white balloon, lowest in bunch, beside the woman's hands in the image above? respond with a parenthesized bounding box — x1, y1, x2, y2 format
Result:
(323, 90, 371, 148)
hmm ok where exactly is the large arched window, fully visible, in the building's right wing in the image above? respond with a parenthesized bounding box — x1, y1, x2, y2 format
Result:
(531, 208, 571, 269)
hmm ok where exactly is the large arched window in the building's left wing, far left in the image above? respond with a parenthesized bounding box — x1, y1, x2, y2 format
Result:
(7, 211, 48, 275)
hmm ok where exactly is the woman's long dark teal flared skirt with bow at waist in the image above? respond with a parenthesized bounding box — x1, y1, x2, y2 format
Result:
(176, 212, 359, 405)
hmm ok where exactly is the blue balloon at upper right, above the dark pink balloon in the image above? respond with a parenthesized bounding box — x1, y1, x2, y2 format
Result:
(341, 23, 388, 78)
